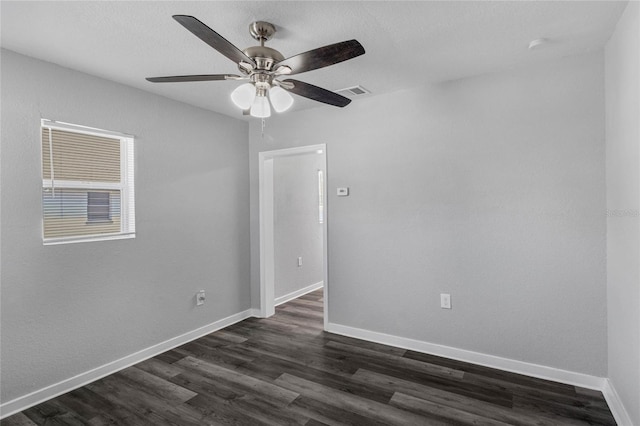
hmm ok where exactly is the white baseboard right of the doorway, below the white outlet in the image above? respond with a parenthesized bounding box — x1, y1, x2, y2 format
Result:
(326, 323, 606, 391)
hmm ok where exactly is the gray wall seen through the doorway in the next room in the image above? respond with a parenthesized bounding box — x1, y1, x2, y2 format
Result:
(273, 154, 324, 298)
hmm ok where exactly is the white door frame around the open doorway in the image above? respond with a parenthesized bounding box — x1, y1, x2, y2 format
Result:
(258, 144, 329, 329)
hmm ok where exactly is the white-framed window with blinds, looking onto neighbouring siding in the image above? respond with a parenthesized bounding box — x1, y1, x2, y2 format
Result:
(41, 120, 135, 244)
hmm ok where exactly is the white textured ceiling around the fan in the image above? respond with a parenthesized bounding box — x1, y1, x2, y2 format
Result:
(0, 0, 626, 119)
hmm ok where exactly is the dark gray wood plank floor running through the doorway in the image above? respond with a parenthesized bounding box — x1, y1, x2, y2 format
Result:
(1, 290, 615, 426)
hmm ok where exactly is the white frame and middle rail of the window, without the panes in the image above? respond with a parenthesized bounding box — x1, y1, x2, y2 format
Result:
(38, 119, 136, 245)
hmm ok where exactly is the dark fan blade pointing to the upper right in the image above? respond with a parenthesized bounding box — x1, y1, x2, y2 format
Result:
(274, 40, 364, 75)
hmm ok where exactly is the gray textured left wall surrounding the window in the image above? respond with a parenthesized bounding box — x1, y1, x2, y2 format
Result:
(1, 50, 251, 402)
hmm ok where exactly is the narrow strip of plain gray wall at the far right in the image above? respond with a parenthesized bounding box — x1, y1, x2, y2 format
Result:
(606, 2, 640, 425)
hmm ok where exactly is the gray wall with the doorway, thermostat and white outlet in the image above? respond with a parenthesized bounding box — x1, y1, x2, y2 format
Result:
(250, 52, 607, 376)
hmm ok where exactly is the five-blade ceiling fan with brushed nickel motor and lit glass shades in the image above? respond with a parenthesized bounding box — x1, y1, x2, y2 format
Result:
(147, 15, 365, 118)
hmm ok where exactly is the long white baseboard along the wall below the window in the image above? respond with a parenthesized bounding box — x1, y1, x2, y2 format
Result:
(0, 309, 259, 419)
